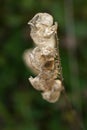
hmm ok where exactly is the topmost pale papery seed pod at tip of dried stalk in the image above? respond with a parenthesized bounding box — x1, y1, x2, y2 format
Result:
(28, 13, 57, 47)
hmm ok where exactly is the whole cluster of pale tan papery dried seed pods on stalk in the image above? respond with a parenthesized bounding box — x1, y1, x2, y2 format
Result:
(24, 13, 63, 103)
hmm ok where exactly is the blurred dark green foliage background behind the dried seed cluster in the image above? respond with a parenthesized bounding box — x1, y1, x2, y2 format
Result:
(0, 0, 87, 130)
